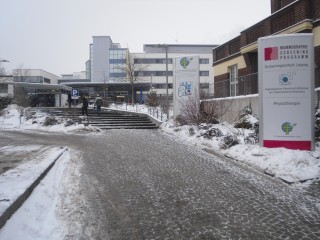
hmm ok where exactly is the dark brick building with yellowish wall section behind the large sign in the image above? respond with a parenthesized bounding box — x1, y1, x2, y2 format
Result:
(213, 0, 320, 97)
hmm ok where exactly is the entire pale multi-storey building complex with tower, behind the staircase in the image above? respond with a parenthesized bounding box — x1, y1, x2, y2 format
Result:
(64, 36, 217, 102)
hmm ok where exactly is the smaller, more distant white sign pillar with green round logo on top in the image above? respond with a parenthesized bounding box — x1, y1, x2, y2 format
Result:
(173, 56, 200, 118)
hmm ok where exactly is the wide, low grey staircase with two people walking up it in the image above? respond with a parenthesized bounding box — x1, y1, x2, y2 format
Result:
(36, 108, 160, 129)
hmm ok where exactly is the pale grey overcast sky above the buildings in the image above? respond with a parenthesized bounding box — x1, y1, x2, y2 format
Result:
(0, 0, 271, 75)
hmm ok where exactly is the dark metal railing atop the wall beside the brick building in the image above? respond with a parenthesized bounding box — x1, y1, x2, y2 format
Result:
(214, 73, 258, 98)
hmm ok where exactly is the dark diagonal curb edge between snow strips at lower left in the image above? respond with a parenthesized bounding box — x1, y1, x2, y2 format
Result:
(0, 148, 68, 229)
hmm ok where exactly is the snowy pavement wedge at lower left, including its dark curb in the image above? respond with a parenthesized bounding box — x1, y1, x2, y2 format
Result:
(0, 145, 66, 228)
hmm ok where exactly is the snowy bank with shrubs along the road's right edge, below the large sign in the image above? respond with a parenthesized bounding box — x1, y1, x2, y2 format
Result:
(161, 109, 320, 183)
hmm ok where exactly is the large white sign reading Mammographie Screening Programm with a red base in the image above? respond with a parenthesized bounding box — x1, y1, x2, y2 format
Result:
(258, 34, 314, 150)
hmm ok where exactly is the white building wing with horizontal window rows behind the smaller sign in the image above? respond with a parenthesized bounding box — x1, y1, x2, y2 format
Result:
(131, 44, 216, 95)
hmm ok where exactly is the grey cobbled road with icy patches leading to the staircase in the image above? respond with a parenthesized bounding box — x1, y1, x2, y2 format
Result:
(0, 130, 320, 239)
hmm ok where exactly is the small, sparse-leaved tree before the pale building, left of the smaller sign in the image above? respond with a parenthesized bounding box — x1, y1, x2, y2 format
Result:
(119, 54, 148, 105)
